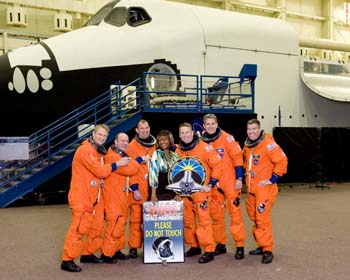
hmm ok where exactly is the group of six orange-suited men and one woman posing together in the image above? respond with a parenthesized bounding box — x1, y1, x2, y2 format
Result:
(61, 114, 288, 272)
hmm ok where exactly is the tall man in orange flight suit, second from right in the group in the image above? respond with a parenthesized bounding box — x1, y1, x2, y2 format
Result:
(202, 114, 246, 260)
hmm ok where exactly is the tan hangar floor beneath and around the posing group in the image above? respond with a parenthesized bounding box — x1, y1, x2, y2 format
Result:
(0, 183, 350, 280)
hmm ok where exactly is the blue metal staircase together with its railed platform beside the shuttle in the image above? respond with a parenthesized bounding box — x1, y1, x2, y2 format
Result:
(0, 64, 256, 208)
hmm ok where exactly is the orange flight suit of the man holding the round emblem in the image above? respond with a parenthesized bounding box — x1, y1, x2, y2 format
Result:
(175, 136, 223, 253)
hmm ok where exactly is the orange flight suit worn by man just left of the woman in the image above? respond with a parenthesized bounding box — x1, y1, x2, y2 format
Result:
(126, 136, 156, 248)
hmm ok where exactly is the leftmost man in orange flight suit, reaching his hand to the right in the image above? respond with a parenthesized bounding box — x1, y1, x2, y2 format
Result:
(61, 124, 130, 272)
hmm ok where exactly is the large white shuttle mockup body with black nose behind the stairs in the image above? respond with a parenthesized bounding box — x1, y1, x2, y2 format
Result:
(0, 0, 350, 136)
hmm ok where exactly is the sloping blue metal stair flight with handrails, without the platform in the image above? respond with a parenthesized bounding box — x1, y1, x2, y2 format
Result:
(0, 79, 142, 207)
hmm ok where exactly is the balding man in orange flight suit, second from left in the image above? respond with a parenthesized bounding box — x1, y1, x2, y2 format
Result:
(101, 133, 144, 264)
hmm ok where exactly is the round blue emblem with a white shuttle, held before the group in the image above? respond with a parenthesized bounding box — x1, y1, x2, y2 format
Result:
(165, 157, 206, 196)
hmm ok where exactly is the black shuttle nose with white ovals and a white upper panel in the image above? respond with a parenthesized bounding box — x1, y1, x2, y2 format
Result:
(0, 44, 59, 136)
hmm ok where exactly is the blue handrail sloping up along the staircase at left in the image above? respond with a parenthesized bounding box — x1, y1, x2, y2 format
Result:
(0, 79, 141, 190)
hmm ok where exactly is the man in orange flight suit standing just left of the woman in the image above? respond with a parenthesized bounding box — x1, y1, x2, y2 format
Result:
(126, 120, 157, 258)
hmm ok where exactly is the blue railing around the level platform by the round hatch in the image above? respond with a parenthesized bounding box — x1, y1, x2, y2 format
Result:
(142, 68, 256, 114)
